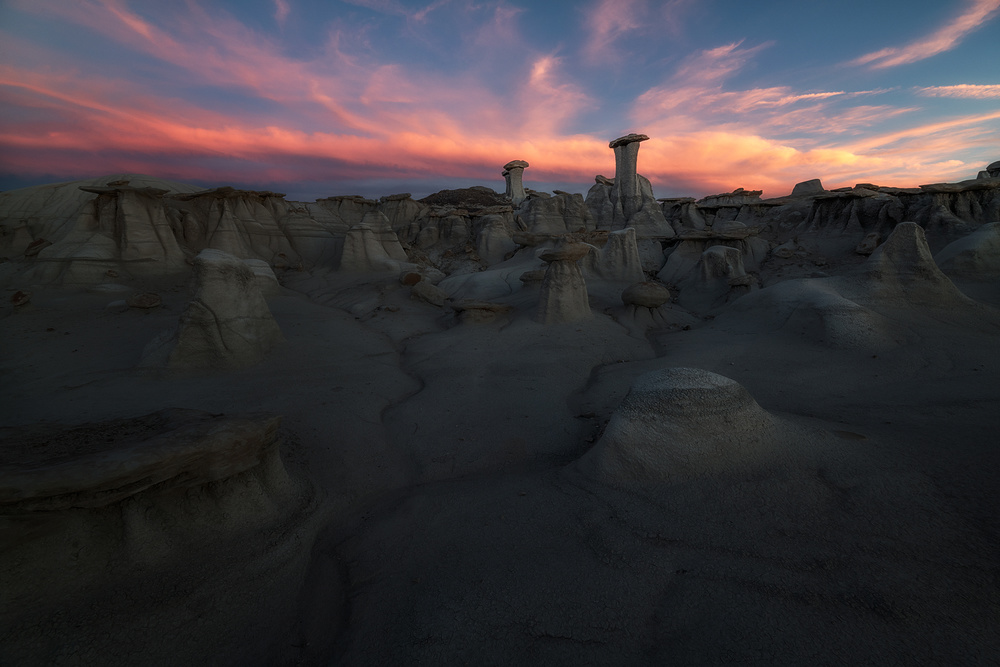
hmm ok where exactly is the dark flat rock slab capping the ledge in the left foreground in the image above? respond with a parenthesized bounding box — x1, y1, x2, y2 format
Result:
(0, 409, 281, 514)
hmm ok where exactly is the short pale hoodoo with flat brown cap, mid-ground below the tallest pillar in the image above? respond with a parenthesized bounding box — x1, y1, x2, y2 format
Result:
(537, 242, 593, 324)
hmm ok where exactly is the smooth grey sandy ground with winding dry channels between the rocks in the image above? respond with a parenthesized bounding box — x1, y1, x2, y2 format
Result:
(0, 235, 1000, 665)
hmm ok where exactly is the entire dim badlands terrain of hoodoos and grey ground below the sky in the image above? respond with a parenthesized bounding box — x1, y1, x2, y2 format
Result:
(0, 149, 1000, 665)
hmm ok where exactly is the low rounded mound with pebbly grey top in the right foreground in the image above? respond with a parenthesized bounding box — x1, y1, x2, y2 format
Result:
(576, 368, 795, 487)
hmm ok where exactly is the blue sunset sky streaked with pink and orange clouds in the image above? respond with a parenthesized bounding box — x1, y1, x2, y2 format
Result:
(0, 0, 1000, 201)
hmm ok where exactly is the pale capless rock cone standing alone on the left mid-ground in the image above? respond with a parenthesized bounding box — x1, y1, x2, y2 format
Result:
(140, 249, 283, 371)
